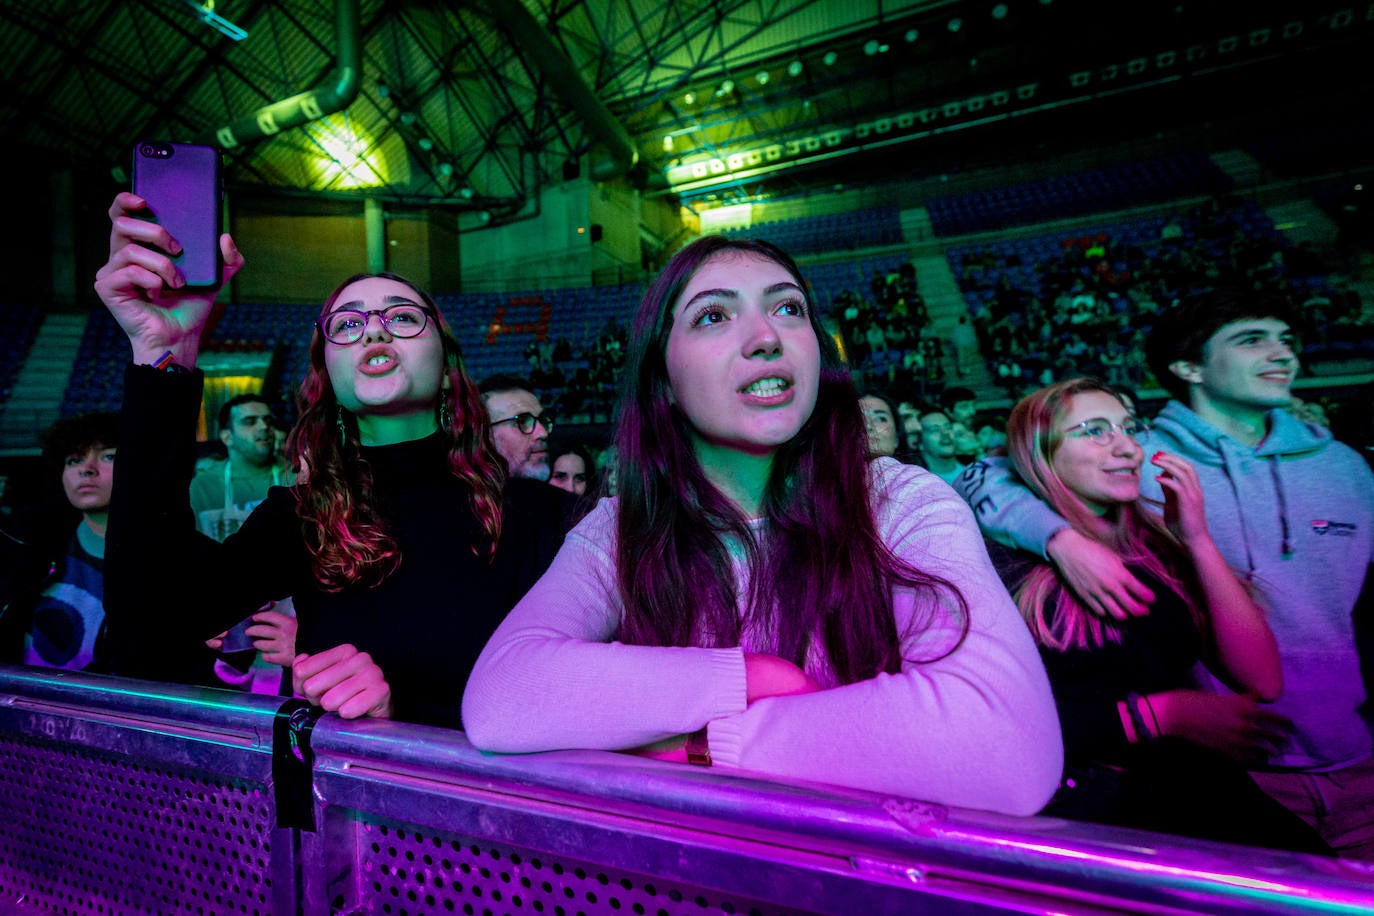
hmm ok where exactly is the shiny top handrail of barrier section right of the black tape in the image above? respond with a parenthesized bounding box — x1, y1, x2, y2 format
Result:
(312, 717, 1374, 913)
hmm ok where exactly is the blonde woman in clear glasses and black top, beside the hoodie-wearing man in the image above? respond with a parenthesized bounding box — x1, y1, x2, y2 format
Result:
(999, 378, 1325, 851)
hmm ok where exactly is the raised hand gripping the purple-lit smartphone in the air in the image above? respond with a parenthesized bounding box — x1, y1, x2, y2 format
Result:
(95, 191, 243, 368)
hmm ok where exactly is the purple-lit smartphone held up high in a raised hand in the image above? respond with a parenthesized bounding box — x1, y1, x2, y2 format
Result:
(133, 141, 224, 288)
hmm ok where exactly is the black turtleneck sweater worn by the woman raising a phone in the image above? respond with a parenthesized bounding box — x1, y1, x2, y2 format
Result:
(106, 367, 570, 728)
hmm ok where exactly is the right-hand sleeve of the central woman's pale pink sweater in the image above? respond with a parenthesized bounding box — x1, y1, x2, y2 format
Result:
(708, 459, 1063, 814)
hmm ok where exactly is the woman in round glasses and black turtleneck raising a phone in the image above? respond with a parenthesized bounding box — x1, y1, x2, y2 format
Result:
(96, 194, 566, 726)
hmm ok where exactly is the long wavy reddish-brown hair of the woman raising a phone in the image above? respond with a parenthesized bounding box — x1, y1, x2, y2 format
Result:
(286, 273, 506, 592)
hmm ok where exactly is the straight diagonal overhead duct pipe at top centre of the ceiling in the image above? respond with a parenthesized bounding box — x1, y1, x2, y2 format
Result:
(480, 0, 639, 181)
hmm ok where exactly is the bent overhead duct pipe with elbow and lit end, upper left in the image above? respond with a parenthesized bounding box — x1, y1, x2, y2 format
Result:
(198, 0, 363, 150)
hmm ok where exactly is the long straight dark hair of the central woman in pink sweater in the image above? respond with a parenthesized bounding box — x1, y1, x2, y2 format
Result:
(616, 236, 967, 684)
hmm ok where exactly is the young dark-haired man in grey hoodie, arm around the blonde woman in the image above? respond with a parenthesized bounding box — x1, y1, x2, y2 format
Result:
(955, 290, 1374, 860)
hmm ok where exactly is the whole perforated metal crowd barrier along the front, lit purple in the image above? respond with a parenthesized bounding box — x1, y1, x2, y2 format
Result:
(0, 666, 1374, 916)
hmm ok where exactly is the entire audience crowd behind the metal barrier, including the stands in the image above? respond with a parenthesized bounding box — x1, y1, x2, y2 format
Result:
(0, 186, 1374, 860)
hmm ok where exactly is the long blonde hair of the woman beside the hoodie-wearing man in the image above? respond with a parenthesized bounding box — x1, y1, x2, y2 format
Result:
(1007, 378, 1205, 652)
